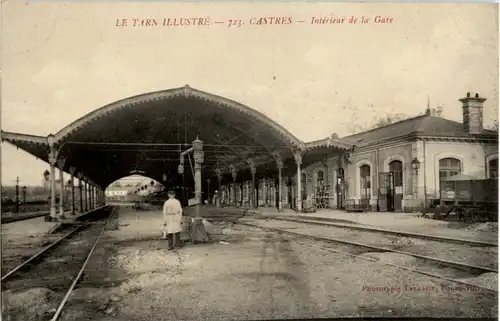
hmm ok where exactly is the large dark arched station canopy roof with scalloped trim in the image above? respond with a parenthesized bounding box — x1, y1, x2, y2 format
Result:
(2, 85, 351, 187)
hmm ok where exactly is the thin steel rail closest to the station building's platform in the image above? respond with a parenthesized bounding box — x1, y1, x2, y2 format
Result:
(256, 216, 498, 247)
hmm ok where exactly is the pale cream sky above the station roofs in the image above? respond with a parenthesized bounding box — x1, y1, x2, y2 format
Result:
(1, 1, 498, 185)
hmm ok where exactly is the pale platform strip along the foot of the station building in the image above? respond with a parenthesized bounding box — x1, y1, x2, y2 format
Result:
(213, 206, 498, 243)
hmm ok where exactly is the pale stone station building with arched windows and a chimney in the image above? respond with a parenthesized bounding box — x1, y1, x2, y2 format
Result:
(222, 93, 498, 212)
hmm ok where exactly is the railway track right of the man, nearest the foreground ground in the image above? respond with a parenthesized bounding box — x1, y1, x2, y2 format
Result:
(234, 218, 498, 293)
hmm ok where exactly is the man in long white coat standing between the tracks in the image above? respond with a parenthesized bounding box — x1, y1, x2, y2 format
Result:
(163, 190, 182, 250)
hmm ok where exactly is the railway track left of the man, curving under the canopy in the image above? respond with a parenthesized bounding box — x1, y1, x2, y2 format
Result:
(1, 207, 117, 321)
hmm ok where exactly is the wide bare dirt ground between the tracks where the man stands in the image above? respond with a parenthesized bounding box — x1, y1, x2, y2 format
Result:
(4, 208, 490, 321)
